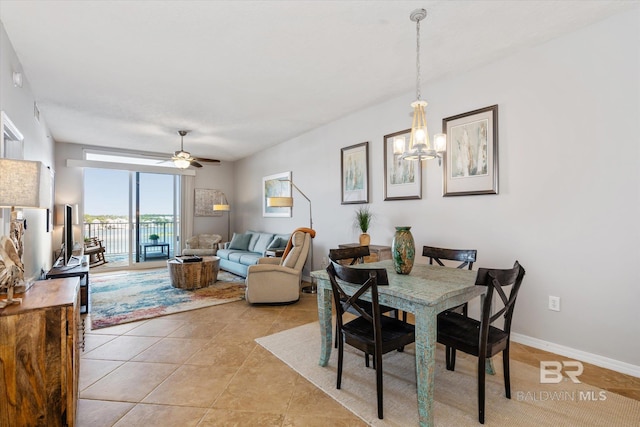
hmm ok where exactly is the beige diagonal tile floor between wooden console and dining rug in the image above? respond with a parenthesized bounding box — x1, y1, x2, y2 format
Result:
(78, 294, 640, 427)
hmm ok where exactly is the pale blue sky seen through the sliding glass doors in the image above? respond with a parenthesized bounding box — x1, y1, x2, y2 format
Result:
(84, 168, 174, 216)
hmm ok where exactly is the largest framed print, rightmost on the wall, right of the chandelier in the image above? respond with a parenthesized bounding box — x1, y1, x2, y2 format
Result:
(442, 105, 498, 196)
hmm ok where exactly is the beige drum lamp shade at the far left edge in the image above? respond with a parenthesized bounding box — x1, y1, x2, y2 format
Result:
(0, 159, 51, 209)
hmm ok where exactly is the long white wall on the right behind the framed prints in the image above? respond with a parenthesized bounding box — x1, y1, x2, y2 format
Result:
(234, 8, 640, 374)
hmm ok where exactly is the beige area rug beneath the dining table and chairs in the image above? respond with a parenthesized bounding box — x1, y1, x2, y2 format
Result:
(256, 323, 640, 427)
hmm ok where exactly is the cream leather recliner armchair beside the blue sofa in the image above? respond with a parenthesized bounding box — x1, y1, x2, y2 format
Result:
(245, 231, 315, 304)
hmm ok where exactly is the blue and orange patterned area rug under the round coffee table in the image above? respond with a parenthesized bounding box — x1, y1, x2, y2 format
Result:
(89, 268, 245, 329)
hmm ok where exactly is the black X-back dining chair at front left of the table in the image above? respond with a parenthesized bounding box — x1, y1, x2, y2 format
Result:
(327, 261, 416, 419)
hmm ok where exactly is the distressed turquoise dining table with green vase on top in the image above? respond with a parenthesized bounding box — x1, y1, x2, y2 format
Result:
(311, 260, 486, 426)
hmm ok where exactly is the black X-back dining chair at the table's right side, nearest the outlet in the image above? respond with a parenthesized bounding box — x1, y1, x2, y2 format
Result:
(438, 261, 525, 424)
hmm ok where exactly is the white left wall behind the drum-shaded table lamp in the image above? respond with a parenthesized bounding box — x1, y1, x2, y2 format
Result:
(0, 22, 53, 280)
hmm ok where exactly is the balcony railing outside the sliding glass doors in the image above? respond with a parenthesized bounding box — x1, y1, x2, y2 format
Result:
(82, 221, 180, 256)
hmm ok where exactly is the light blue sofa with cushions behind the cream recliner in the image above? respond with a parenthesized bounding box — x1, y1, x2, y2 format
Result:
(216, 230, 290, 277)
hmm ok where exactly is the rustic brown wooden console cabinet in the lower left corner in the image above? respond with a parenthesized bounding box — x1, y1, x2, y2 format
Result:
(0, 277, 80, 427)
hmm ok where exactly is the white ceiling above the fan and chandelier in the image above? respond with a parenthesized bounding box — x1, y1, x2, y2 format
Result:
(0, 0, 638, 161)
